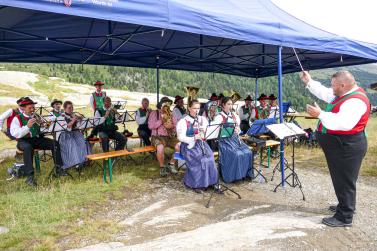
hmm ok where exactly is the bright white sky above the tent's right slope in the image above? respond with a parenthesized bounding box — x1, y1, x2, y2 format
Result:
(272, 0, 377, 44)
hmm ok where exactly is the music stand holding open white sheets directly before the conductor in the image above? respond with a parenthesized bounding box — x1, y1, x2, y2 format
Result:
(268, 123, 305, 200)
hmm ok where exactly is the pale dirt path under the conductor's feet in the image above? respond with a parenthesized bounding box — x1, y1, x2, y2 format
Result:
(63, 166, 377, 250)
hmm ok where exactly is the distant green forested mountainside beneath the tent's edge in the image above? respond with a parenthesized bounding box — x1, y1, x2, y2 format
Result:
(0, 64, 377, 110)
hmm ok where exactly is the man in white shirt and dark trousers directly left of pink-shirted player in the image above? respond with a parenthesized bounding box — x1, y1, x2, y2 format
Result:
(135, 98, 152, 146)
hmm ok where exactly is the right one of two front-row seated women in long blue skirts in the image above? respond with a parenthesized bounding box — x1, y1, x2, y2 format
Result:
(213, 97, 253, 183)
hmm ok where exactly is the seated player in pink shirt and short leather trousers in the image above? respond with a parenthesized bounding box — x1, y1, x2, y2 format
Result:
(148, 97, 179, 177)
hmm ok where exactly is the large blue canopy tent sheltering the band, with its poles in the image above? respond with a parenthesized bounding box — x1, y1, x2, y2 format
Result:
(0, 0, 377, 187)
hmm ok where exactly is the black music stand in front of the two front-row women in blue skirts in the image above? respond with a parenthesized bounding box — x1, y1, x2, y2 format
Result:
(204, 123, 241, 208)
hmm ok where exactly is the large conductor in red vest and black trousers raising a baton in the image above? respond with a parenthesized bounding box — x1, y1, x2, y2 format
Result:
(300, 71, 370, 227)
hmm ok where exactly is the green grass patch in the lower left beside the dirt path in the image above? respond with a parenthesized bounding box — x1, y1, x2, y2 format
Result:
(0, 154, 159, 250)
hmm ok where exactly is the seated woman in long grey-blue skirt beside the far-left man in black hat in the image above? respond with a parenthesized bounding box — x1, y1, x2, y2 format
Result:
(57, 101, 91, 169)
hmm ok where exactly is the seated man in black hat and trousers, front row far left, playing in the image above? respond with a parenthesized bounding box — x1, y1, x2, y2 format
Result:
(10, 98, 66, 186)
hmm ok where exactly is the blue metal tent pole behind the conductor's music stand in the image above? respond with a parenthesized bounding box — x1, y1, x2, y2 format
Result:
(278, 46, 285, 188)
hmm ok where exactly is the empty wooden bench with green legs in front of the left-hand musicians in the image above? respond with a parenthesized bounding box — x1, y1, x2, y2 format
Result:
(86, 146, 156, 182)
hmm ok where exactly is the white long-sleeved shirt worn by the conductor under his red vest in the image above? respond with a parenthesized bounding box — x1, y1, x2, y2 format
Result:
(306, 80, 368, 131)
